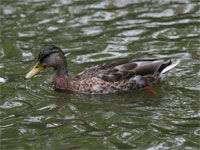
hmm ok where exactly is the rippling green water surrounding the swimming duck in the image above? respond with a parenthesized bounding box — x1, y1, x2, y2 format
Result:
(0, 0, 200, 150)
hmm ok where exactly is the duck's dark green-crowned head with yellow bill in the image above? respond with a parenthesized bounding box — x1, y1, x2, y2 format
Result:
(25, 45, 67, 79)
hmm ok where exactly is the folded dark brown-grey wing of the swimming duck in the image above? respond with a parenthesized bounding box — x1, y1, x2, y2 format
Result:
(75, 59, 177, 82)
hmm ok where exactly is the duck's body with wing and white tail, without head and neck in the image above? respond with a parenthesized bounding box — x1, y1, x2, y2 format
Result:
(67, 59, 179, 94)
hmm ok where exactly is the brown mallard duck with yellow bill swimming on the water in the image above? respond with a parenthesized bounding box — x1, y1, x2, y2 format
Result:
(25, 46, 180, 94)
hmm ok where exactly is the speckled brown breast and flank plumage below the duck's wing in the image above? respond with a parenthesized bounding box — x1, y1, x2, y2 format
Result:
(53, 74, 161, 94)
